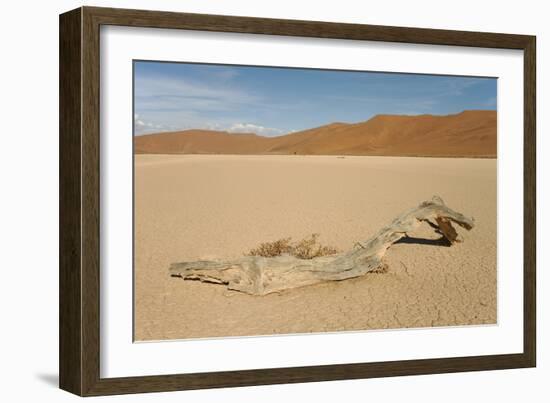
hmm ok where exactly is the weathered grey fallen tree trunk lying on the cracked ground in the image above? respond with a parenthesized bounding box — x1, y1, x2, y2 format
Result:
(170, 196, 474, 295)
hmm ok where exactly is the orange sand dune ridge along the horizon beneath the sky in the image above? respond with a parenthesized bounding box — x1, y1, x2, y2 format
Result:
(134, 110, 497, 158)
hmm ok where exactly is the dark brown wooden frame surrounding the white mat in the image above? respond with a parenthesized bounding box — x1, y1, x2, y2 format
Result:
(59, 7, 536, 396)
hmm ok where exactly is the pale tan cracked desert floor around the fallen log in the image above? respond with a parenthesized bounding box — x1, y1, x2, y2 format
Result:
(135, 155, 497, 340)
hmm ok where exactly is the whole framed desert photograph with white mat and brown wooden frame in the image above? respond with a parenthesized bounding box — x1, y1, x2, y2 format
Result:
(60, 7, 536, 396)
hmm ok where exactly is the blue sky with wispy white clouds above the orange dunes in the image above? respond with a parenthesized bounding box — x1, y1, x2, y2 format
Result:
(134, 61, 497, 136)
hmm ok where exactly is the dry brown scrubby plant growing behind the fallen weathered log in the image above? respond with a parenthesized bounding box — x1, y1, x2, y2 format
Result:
(247, 234, 338, 259)
